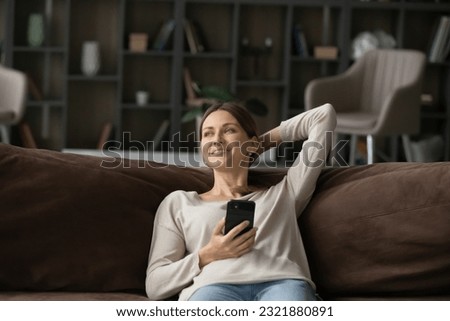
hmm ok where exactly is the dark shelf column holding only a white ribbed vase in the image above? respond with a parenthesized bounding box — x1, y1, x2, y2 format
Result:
(66, 0, 121, 149)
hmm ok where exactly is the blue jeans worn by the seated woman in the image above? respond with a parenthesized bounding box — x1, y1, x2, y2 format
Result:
(189, 279, 317, 301)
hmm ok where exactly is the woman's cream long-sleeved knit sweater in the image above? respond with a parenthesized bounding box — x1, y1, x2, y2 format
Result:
(145, 104, 336, 300)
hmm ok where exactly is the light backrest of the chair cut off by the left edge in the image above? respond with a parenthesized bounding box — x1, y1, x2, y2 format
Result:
(0, 65, 27, 125)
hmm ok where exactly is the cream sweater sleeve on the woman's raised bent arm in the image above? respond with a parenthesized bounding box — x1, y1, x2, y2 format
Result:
(280, 104, 336, 215)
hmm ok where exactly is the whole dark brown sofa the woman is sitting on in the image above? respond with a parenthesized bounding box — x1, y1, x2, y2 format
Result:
(0, 144, 450, 300)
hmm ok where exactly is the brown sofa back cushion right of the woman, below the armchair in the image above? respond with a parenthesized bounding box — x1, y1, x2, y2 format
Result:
(300, 162, 450, 298)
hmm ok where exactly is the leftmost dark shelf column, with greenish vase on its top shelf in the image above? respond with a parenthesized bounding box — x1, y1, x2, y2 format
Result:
(6, 0, 68, 149)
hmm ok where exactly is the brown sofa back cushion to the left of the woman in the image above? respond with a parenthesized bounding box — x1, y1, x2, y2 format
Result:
(0, 144, 211, 292)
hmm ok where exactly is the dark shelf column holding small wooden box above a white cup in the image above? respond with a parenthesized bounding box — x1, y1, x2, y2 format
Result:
(118, 0, 179, 149)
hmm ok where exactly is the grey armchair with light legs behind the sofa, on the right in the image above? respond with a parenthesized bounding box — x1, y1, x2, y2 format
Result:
(305, 49, 426, 164)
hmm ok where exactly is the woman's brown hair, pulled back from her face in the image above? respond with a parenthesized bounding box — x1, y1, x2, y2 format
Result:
(198, 102, 258, 140)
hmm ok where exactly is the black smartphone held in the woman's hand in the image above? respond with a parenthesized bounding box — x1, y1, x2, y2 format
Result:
(225, 200, 255, 236)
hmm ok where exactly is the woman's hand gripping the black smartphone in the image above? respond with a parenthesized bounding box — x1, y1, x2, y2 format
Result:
(198, 218, 256, 268)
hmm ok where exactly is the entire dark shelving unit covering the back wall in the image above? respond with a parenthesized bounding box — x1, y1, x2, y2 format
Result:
(0, 0, 450, 160)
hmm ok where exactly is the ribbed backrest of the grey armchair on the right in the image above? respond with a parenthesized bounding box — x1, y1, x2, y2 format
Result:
(356, 49, 425, 113)
